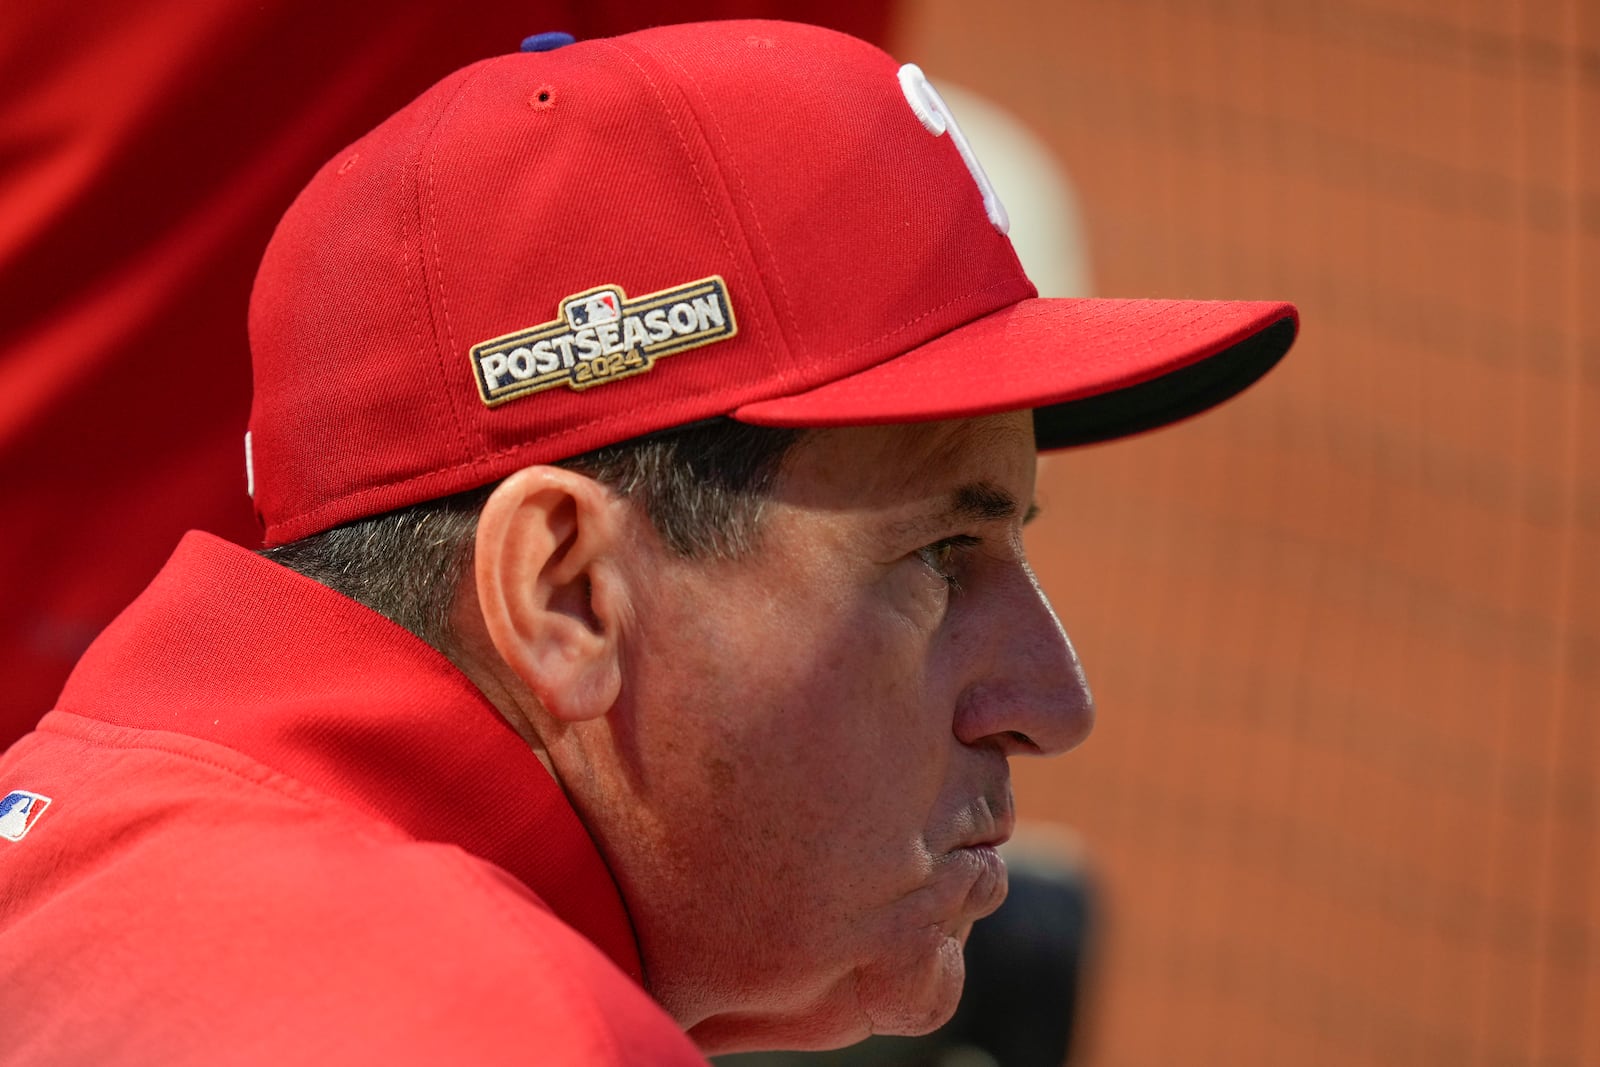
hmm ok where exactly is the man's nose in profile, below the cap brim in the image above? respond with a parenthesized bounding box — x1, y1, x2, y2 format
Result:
(955, 565, 1094, 755)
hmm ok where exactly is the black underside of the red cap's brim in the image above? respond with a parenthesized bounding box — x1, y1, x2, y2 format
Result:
(1034, 317, 1294, 451)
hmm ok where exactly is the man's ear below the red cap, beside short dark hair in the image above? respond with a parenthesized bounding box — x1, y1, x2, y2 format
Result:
(475, 467, 622, 721)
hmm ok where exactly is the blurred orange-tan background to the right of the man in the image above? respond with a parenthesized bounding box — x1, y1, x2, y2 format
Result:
(894, 0, 1600, 1067)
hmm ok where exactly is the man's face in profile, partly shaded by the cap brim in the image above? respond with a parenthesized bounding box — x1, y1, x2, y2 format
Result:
(574, 413, 1093, 1051)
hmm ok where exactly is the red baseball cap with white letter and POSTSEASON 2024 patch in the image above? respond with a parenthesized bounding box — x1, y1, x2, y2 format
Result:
(246, 21, 1296, 544)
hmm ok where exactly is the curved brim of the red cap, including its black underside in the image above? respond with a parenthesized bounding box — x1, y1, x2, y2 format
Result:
(733, 298, 1299, 448)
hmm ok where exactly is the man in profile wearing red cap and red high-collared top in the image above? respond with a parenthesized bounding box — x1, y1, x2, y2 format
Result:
(0, 22, 1294, 1064)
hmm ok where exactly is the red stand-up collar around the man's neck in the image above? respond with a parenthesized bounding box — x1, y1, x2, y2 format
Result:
(58, 533, 642, 981)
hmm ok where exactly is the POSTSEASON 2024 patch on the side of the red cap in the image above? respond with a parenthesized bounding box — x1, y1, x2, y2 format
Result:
(470, 275, 739, 408)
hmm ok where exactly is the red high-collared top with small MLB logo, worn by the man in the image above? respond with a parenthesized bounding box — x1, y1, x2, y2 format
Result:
(0, 533, 706, 1065)
